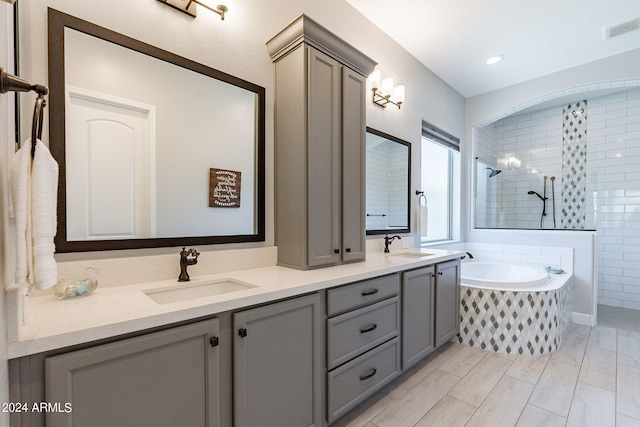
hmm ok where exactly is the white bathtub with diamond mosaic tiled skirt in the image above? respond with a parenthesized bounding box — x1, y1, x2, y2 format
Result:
(459, 261, 573, 355)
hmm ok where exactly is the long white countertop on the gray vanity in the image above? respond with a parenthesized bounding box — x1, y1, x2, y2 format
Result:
(8, 249, 466, 359)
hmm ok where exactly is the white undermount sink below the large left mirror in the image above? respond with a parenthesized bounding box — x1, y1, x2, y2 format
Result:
(142, 279, 257, 304)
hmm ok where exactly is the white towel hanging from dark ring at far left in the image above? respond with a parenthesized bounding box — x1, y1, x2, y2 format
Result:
(11, 140, 58, 289)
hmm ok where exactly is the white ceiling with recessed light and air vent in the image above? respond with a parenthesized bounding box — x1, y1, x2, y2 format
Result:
(346, 0, 640, 97)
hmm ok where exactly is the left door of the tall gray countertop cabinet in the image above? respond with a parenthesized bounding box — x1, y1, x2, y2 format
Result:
(307, 47, 341, 267)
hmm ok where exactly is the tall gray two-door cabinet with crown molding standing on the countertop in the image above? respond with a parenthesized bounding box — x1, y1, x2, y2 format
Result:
(267, 15, 376, 269)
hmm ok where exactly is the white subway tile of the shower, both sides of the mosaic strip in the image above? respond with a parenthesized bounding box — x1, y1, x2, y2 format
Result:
(476, 86, 640, 310)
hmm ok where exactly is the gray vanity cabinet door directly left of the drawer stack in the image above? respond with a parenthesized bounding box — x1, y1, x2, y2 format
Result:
(234, 294, 324, 427)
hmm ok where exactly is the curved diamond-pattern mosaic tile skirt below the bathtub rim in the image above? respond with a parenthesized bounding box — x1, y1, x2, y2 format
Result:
(459, 279, 573, 355)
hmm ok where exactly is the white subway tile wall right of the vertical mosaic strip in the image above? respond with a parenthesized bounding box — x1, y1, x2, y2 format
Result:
(587, 89, 640, 310)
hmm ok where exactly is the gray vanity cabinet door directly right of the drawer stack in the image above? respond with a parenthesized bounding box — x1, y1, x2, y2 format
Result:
(402, 266, 435, 370)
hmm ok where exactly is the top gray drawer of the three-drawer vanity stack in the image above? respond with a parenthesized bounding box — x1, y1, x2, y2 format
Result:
(327, 274, 400, 316)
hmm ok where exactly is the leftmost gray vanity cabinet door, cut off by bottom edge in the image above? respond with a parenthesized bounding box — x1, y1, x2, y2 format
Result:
(45, 319, 220, 427)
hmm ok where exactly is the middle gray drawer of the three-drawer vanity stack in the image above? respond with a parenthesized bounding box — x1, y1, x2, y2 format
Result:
(327, 297, 400, 369)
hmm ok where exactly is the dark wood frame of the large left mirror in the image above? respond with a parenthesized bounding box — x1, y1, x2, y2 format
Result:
(48, 8, 265, 252)
